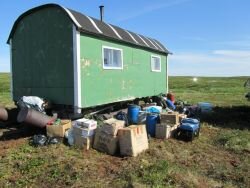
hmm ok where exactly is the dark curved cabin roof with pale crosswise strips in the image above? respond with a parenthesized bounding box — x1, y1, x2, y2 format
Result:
(7, 4, 170, 54)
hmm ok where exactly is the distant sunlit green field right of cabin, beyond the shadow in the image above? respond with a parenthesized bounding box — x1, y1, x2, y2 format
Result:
(169, 77, 249, 107)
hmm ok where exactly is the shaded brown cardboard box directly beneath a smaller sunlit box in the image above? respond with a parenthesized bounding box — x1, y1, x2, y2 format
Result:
(93, 128, 118, 155)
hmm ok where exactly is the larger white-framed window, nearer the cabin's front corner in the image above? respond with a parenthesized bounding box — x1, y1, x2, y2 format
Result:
(102, 46, 123, 69)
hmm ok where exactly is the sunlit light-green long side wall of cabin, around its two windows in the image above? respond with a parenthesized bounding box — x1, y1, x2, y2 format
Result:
(80, 34, 167, 107)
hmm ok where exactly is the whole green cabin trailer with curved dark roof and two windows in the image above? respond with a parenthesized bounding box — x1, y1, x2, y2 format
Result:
(7, 4, 172, 108)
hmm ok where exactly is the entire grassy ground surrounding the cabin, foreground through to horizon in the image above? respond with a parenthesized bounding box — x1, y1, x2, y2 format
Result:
(0, 74, 250, 187)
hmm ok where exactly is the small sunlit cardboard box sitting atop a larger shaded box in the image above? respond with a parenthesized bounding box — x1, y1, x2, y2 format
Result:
(101, 118, 125, 136)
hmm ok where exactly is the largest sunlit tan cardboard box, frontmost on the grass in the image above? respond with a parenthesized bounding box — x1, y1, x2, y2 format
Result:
(118, 125, 148, 157)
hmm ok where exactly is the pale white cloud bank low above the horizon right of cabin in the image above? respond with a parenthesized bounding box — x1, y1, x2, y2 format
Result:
(169, 50, 250, 76)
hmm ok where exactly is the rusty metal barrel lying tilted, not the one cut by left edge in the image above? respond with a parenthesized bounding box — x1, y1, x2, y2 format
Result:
(17, 108, 56, 128)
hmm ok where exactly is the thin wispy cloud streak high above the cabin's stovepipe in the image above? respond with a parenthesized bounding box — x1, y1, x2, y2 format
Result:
(117, 0, 190, 22)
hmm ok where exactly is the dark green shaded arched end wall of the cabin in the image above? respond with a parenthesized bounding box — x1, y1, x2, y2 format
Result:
(12, 7, 74, 105)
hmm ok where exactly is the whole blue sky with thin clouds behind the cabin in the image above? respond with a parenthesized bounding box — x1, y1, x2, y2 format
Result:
(0, 0, 250, 76)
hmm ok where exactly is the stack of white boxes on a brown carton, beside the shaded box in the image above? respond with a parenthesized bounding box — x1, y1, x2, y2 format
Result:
(73, 118, 97, 150)
